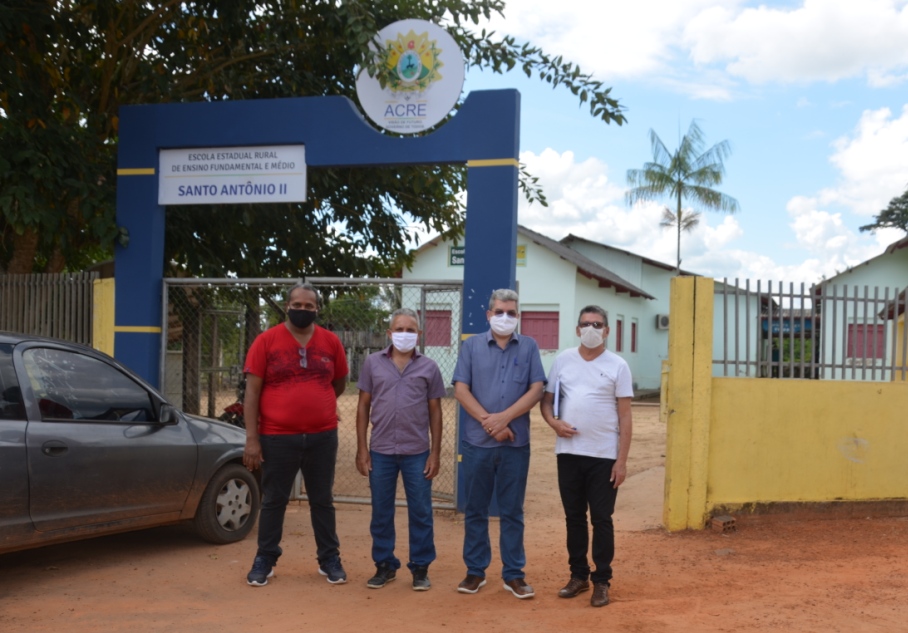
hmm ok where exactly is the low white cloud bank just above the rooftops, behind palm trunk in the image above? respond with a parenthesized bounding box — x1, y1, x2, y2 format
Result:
(519, 149, 902, 284)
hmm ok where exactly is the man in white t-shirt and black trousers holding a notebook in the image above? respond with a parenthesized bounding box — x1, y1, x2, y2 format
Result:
(540, 306, 634, 607)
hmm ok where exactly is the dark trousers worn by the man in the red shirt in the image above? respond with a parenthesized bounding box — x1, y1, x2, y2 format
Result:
(256, 429, 340, 565)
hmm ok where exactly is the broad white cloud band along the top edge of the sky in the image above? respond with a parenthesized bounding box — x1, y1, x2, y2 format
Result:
(476, 0, 908, 90)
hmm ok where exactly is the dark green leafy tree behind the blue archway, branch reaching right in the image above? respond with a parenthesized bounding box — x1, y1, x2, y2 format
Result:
(0, 0, 624, 276)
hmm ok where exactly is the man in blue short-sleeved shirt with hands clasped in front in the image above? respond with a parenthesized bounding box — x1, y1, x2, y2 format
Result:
(453, 289, 545, 599)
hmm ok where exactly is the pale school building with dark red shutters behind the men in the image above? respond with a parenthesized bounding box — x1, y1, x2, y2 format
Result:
(402, 226, 674, 390)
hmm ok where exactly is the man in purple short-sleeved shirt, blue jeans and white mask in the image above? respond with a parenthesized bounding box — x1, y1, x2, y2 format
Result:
(356, 308, 445, 591)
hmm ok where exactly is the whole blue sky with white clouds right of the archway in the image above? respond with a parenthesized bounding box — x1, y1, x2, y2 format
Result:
(454, 0, 908, 283)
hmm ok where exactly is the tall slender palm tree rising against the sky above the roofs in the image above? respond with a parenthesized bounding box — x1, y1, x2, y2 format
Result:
(626, 121, 738, 274)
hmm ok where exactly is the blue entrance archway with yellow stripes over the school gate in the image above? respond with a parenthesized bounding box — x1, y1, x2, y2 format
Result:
(114, 90, 520, 385)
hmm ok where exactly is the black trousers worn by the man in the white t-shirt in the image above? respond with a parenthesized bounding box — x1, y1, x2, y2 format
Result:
(558, 453, 618, 584)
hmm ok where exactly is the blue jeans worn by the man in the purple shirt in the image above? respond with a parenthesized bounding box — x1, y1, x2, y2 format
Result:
(369, 451, 435, 571)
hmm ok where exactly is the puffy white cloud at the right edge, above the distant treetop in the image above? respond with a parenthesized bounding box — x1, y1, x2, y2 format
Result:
(820, 105, 908, 217)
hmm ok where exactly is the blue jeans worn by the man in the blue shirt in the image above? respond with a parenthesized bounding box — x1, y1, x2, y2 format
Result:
(460, 442, 530, 582)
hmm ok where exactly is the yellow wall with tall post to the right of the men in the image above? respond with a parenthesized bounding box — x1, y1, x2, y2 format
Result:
(661, 277, 908, 531)
